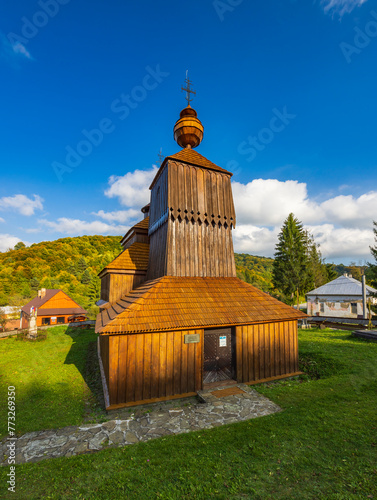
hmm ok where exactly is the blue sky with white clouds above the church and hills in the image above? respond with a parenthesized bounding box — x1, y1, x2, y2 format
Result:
(0, 0, 377, 264)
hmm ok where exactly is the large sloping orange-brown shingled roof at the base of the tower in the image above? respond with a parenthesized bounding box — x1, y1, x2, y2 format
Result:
(96, 276, 306, 335)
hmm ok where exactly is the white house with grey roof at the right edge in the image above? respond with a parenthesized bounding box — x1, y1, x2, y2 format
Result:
(306, 274, 377, 318)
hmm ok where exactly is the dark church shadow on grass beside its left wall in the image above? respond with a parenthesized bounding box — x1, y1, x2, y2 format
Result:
(64, 326, 106, 420)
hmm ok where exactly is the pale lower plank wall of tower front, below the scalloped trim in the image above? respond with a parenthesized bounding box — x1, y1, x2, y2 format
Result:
(165, 216, 236, 277)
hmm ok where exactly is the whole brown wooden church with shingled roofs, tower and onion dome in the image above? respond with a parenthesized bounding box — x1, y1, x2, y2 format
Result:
(96, 81, 305, 409)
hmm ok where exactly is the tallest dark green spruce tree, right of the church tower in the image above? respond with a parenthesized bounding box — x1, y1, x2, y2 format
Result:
(272, 213, 309, 307)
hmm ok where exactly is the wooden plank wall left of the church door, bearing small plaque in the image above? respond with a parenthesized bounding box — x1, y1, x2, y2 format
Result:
(107, 330, 203, 406)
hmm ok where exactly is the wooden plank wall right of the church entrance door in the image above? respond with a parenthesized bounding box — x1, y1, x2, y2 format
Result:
(236, 320, 298, 383)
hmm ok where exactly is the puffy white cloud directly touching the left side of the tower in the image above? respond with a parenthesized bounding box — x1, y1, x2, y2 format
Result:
(105, 165, 158, 208)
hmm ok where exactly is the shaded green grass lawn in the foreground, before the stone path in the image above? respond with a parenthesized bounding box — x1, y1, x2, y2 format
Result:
(0, 330, 377, 500)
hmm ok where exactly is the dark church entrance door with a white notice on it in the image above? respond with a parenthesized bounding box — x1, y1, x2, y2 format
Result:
(203, 328, 234, 384)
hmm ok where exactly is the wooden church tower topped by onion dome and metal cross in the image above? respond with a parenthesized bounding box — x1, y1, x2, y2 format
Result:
(147, 79, 236, 279)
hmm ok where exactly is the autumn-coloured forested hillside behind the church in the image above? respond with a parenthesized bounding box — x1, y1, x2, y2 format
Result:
(0, 236, 367, 317)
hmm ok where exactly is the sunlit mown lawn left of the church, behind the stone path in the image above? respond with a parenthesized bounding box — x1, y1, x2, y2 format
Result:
(0, 326, 105, 438)
